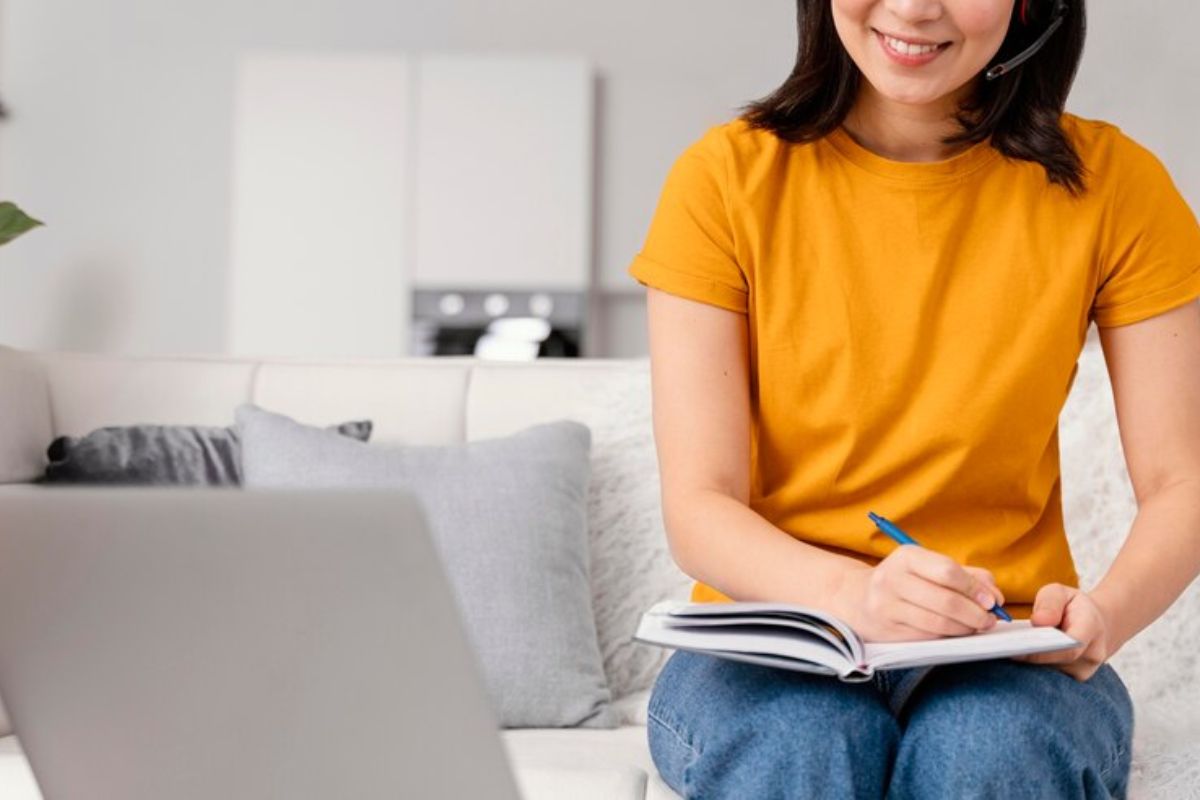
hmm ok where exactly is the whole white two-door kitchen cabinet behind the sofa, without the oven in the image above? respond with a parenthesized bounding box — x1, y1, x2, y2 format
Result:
(228, 54, 594, 356)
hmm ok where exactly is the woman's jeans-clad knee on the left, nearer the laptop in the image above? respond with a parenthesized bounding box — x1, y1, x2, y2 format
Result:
(648, 651, 900, 800)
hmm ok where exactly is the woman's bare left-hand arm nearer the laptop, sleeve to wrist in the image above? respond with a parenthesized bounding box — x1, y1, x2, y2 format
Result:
(647, 287, 863, 607)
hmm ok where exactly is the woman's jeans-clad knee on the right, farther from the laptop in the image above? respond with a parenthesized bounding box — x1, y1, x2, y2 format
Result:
(888, 661, 1133, 800)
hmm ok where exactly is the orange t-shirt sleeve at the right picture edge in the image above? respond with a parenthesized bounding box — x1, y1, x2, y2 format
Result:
(1092, 134, 1200, 327)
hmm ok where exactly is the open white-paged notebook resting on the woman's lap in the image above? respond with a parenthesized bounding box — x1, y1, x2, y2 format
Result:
(634, 601, 1080, 682)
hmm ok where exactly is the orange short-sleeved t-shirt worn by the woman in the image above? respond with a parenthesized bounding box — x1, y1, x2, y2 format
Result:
(629, 114, 1200, 618)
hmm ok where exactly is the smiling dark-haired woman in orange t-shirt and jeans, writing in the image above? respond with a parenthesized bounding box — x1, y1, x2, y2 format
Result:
(630, 0, 1200, 800)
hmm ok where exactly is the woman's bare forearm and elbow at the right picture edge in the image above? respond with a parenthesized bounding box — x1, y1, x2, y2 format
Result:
(1090, 301, 1200, 655)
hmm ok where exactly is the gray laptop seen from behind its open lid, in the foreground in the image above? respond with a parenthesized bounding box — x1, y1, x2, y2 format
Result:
(0, 487, 518, 800)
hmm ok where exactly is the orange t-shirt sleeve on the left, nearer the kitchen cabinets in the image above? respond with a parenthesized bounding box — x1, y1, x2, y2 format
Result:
(629, 128, 749, 313)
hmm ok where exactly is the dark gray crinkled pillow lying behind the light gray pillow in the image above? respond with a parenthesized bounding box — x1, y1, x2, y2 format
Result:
(37, 420, 373, 486)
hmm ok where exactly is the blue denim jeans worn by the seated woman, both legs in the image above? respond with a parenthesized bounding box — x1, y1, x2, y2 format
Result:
(647, 650, 1133, 800)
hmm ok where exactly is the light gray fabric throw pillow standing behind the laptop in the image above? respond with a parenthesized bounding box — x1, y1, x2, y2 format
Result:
(236, 405, 617, 728)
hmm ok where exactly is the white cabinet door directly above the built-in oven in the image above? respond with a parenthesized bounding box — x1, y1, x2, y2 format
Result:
(413, 55, 593, 290)
